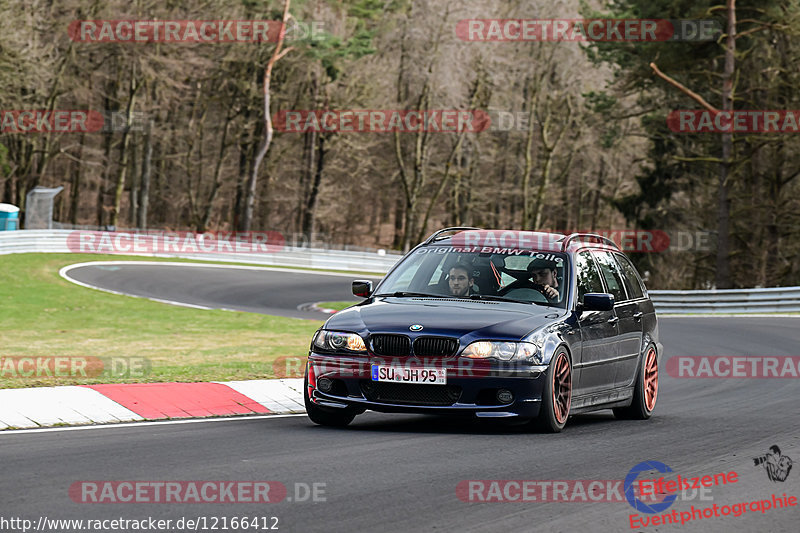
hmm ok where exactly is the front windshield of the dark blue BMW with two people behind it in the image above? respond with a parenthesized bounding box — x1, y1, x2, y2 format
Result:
(376, 244, 569, 308)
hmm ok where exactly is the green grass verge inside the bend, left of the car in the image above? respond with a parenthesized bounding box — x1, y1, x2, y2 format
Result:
(0, 254, 322, 388)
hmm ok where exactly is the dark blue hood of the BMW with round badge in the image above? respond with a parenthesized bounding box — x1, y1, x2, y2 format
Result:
(325, 297, 564, 340)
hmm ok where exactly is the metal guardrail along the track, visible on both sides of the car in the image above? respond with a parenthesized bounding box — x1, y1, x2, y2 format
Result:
(0, 230, 800, 314)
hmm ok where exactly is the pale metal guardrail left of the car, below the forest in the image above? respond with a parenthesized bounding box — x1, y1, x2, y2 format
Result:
(0, 230, 402, 273)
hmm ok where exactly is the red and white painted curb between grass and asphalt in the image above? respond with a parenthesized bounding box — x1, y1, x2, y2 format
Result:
(0, 379, 305, 430)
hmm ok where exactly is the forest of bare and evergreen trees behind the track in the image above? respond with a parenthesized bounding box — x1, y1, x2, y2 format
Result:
(0, 0, 800, 289)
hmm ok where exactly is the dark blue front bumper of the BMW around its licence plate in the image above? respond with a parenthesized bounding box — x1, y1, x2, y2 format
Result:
(306, 352, 547, 418)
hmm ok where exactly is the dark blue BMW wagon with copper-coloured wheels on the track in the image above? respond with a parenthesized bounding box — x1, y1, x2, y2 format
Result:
(304, 228, 662, 432)
